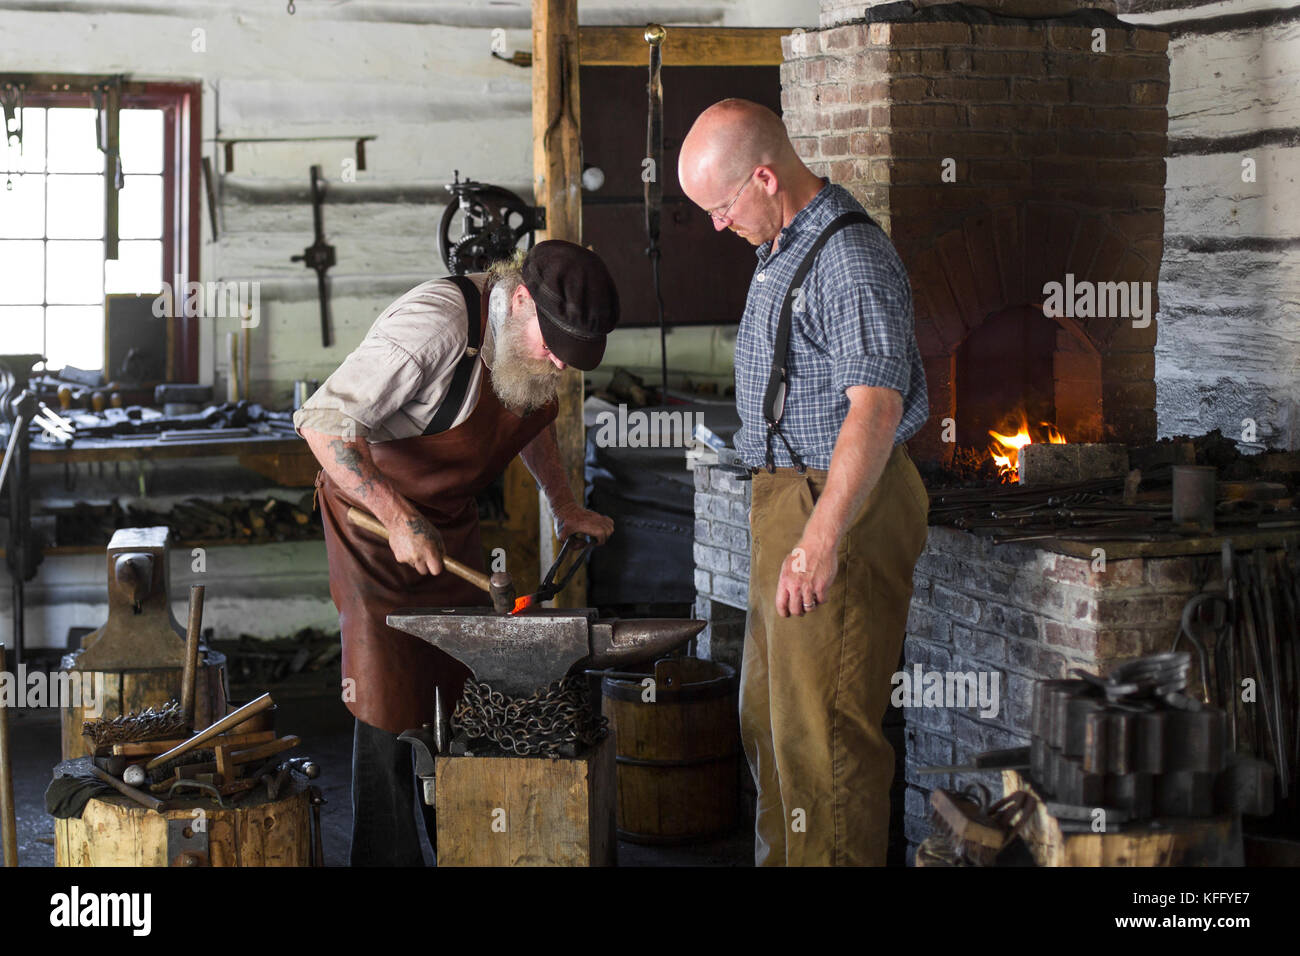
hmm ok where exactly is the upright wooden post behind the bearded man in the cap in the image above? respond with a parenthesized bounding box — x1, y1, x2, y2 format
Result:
(533, 0, 586, 607)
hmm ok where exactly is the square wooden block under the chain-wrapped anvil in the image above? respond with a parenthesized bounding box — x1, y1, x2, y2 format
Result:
(434, 735, 618, 866)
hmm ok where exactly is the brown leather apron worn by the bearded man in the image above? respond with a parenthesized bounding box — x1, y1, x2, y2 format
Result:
(316, 295, 556, 734)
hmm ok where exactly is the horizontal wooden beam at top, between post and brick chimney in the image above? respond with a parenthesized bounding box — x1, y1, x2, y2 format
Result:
(582, 26, 794, 66)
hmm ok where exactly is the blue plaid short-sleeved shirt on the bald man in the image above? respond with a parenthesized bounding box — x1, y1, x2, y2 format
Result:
(735, 179, 930, 470)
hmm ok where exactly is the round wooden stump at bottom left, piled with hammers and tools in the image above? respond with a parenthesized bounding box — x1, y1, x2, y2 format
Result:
(55, 778, 312, 866)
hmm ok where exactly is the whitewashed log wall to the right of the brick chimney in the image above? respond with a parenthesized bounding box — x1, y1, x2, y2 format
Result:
(1125, 0, 1300, 449)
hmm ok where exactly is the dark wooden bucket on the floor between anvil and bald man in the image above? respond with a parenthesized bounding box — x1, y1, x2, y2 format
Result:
(601, 657, 740, 843)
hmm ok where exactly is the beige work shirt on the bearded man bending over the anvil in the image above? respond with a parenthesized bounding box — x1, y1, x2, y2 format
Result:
(294, 273, 491, 444)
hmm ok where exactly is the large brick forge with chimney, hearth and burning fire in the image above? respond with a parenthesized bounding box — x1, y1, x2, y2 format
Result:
(696, 3, 1300, 862)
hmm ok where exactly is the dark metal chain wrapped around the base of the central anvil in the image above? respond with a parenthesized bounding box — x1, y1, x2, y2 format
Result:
(451, 674, 608, 757)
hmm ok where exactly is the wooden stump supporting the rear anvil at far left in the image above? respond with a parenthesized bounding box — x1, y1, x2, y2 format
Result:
(61, 650, 226, 760)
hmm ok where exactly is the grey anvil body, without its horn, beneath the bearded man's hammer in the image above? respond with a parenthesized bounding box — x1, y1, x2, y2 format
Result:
(387, 607, 595, 696)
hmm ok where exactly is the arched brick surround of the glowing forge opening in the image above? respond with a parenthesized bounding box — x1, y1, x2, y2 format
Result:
(898, 200, 1161, 458)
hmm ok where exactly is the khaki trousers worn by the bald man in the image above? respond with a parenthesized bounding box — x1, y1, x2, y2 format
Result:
(740, 445, 928, 866)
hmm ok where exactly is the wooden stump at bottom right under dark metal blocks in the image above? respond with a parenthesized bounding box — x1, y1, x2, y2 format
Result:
(1002, 770, 1243, 866)
